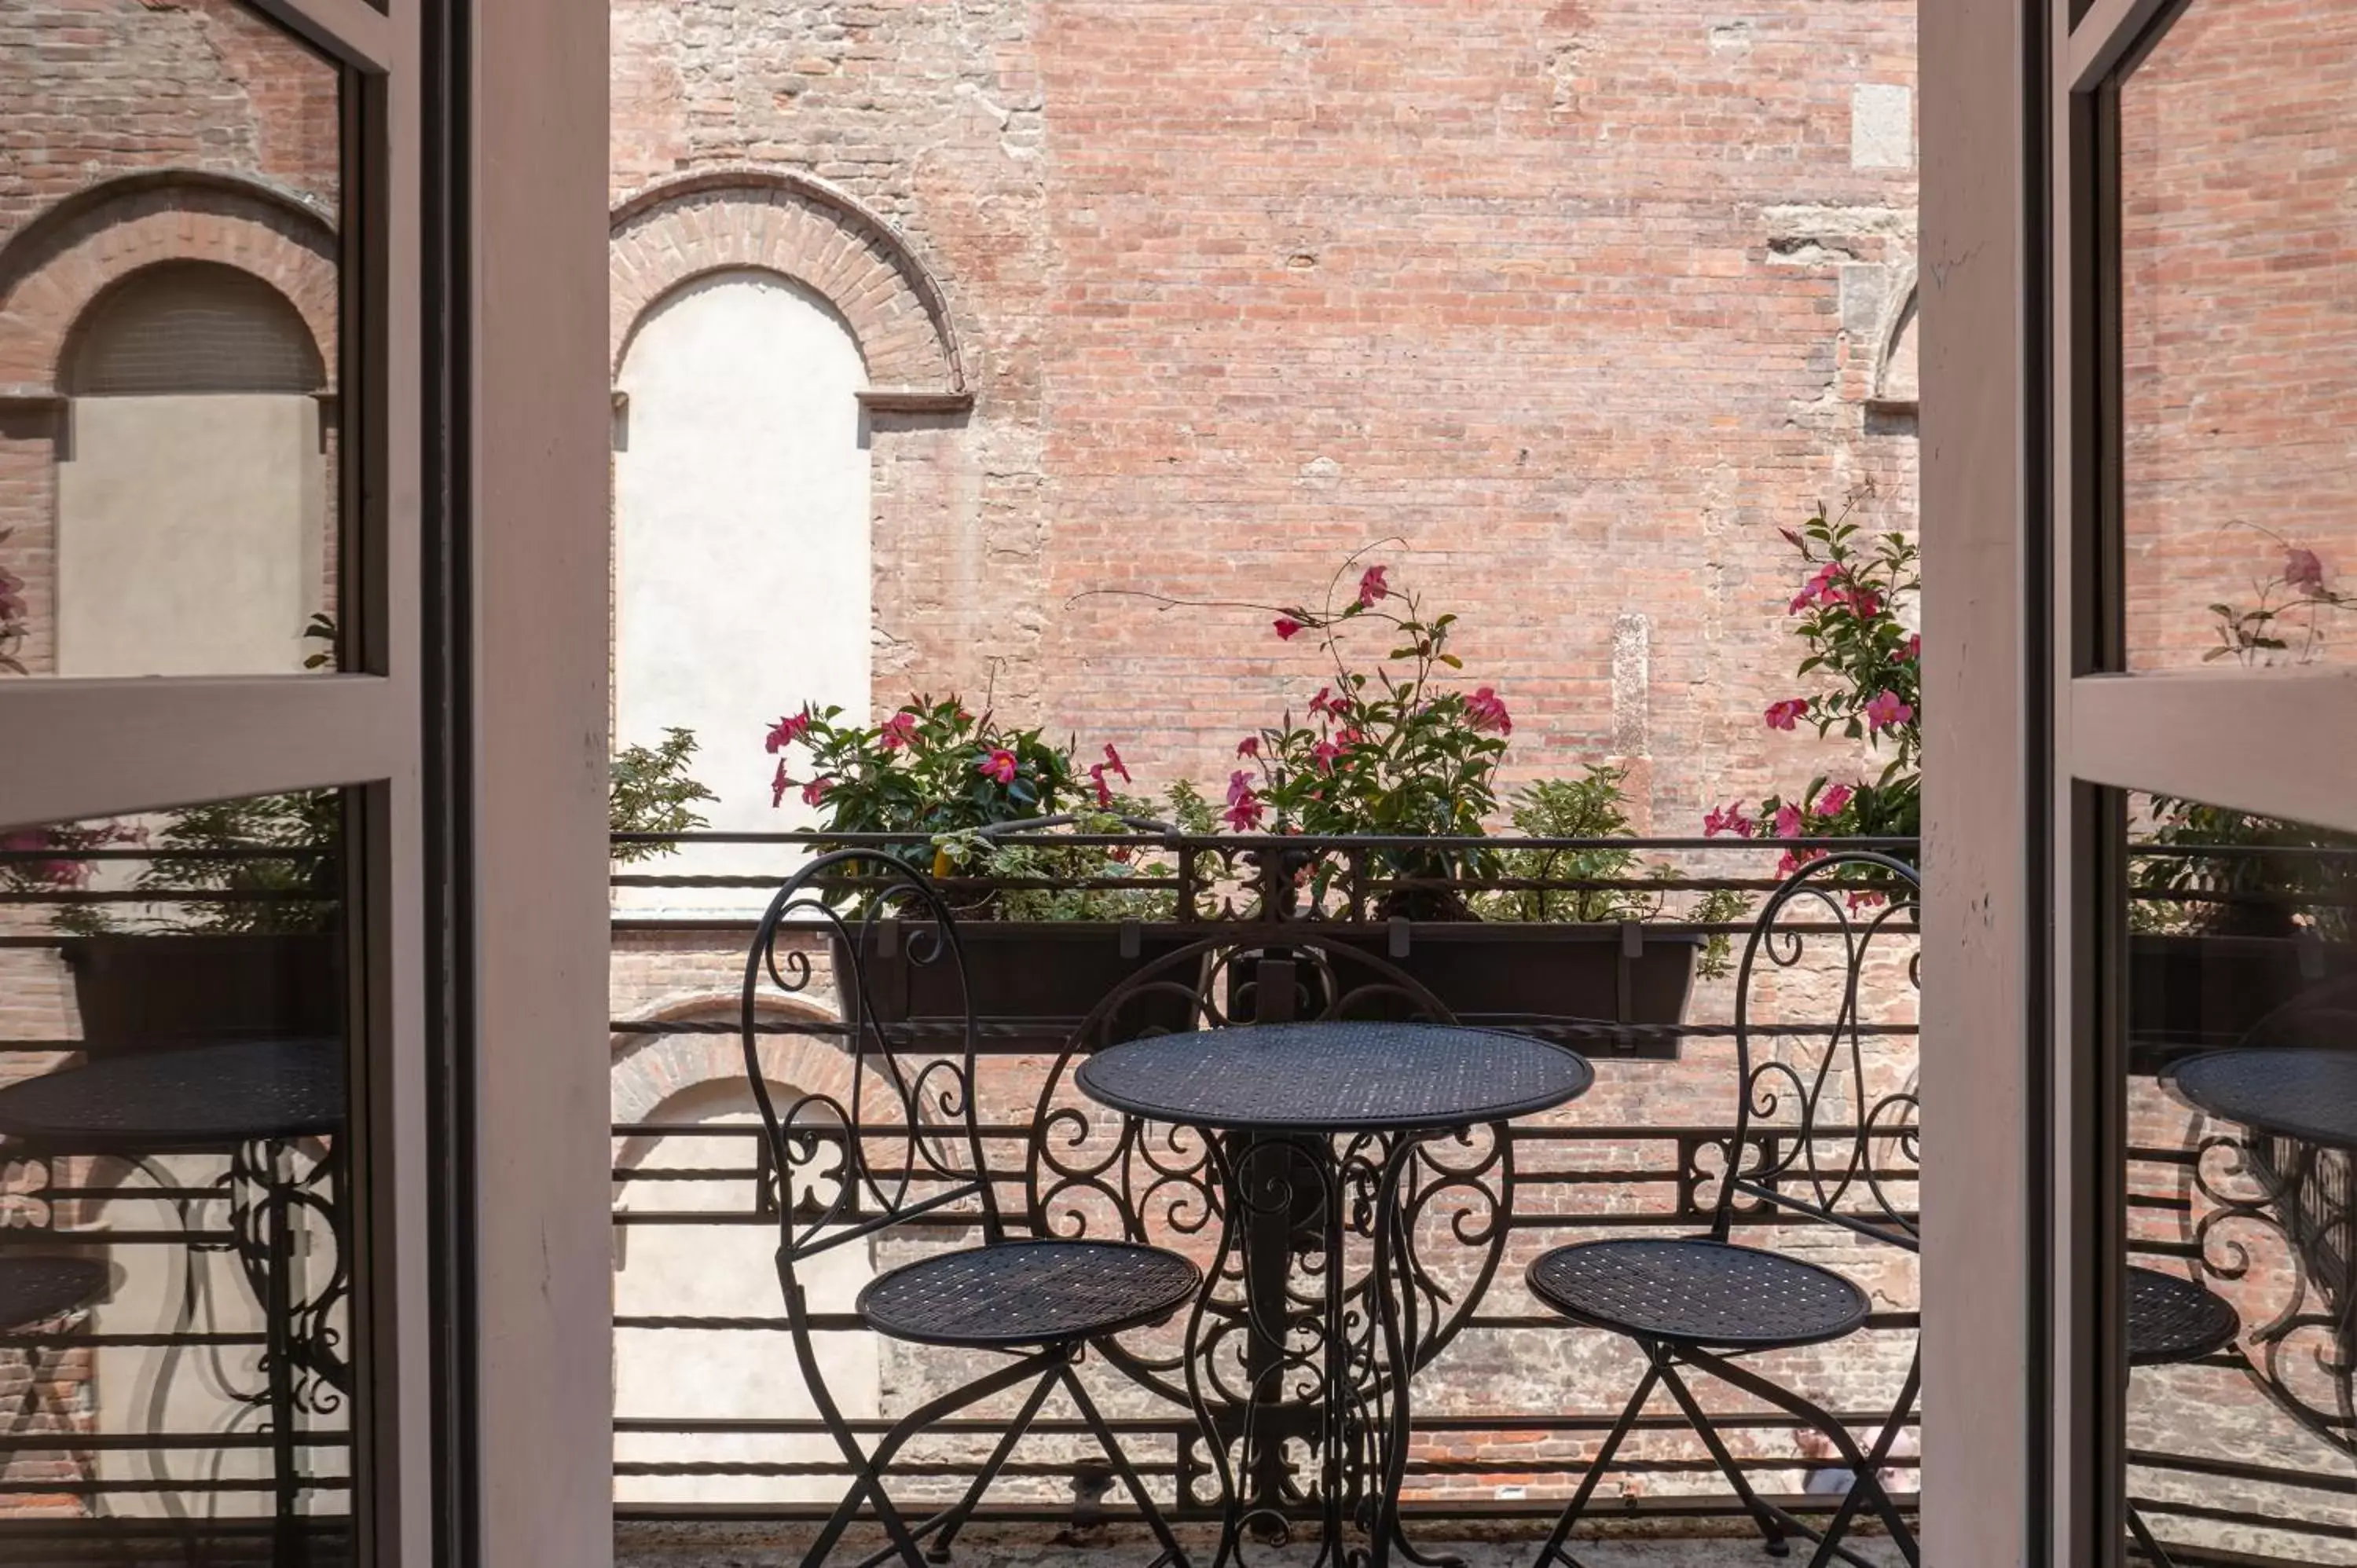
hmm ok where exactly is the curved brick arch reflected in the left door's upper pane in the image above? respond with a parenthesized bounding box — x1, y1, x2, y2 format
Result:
(0, 170, 339, 391)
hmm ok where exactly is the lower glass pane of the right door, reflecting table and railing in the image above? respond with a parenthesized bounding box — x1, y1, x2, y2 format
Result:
(2126, 795, 2357, 1563)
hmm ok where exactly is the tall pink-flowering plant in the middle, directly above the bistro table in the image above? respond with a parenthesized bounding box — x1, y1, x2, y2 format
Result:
(1223, 556, 1513, 835)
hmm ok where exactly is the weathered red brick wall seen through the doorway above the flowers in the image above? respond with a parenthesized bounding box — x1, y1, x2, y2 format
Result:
(613, 0, 1914, 830)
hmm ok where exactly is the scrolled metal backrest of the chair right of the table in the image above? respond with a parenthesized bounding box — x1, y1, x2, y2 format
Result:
(1711, 849, 1921, 1250)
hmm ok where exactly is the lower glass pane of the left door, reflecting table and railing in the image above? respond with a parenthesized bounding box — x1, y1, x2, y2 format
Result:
(0, 790, 356, 1563)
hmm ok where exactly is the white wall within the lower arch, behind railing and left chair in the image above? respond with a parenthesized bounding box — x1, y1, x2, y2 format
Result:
(613, 1083, 882, 1502)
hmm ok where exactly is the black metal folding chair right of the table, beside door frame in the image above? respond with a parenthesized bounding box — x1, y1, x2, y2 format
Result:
(1527, 852, 1921, 1568)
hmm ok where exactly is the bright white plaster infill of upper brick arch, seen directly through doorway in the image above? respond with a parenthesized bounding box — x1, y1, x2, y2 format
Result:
(615, 271, 872, 908)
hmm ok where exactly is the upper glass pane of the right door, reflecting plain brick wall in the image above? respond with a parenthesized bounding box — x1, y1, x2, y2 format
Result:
(2119, 0, 2357, 669)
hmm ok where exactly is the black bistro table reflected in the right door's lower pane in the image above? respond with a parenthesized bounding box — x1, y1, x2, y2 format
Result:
(2168, 1047, 2357, 1453)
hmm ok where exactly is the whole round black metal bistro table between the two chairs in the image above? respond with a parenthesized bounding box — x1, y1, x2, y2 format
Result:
(1075, 1021, 1596, 1568)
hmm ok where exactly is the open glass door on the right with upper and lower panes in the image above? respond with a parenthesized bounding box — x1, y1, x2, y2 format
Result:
(2046, 0, 2357, 1563)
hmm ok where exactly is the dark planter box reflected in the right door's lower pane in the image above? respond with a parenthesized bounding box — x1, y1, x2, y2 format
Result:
(2128, 936, 2357, 1073)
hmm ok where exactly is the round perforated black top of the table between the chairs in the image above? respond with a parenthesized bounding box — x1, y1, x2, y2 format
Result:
(1077, 1021, 1596, 1132)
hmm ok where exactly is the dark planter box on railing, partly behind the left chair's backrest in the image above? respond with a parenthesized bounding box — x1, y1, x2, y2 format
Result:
(834, 920, 1197, 1054)
